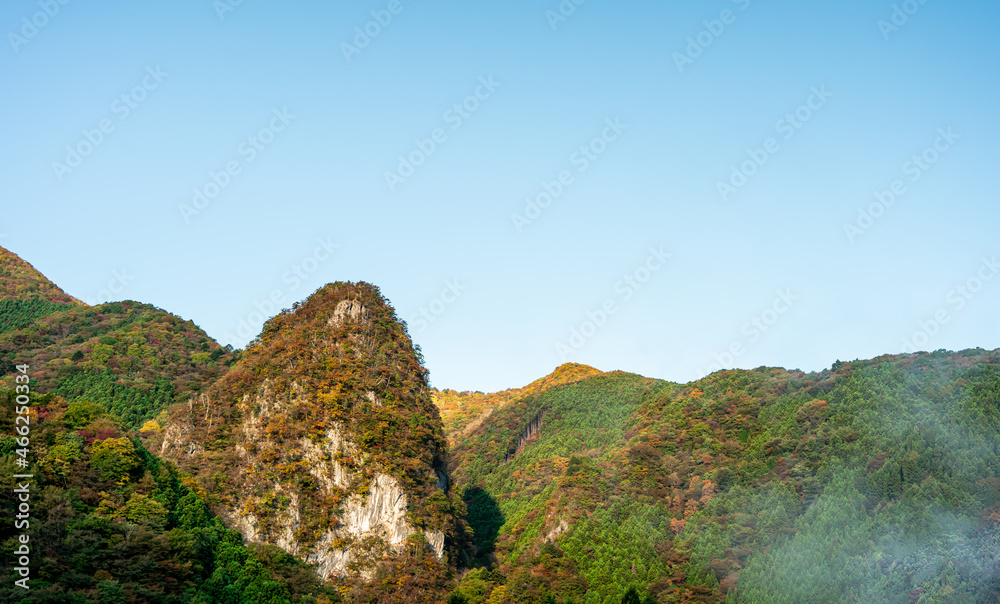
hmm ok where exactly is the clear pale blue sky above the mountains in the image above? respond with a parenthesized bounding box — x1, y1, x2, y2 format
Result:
(0, 0, 1000, 391)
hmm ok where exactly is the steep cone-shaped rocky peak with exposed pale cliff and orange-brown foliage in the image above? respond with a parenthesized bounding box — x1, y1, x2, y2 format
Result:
(150, 283, 460, 577)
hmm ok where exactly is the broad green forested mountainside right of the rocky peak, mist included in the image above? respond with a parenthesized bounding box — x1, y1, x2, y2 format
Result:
(452, 350, 1000, 604)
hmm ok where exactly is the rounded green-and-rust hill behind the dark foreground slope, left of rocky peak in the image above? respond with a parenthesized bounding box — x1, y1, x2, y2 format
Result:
(0, 300, 235, 429)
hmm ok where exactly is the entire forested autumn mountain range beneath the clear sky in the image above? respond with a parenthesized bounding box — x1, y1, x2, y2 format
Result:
(0, 247, 1000, 604)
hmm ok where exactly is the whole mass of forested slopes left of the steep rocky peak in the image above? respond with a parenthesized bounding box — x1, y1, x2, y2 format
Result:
(0, 248, 339, 604)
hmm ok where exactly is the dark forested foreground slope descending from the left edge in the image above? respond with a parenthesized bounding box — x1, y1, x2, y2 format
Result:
(0, 390, 338, 604)
